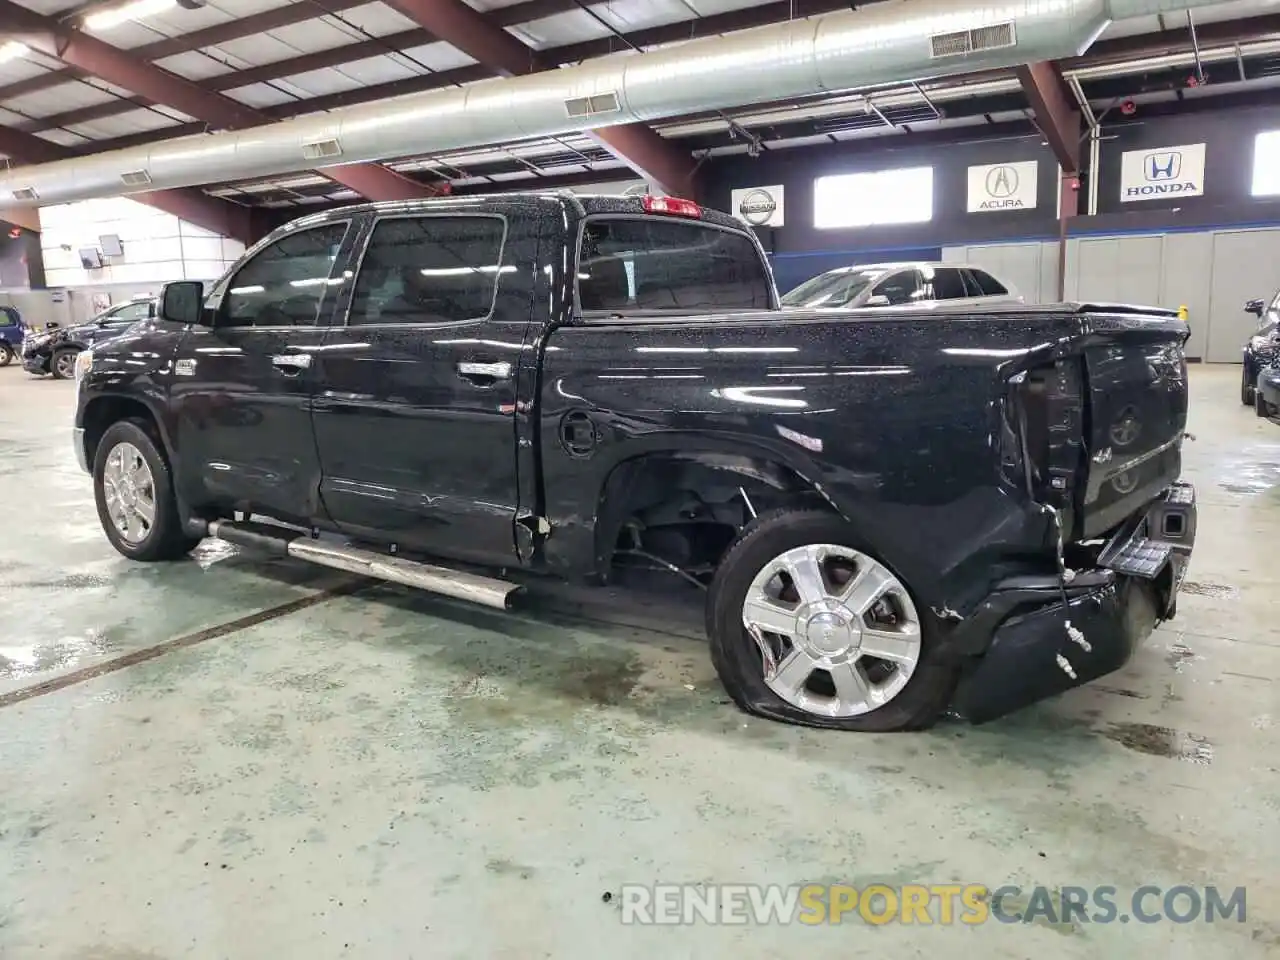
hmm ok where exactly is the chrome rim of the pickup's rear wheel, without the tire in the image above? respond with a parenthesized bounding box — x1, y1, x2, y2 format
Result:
(742, 544, 920, 717)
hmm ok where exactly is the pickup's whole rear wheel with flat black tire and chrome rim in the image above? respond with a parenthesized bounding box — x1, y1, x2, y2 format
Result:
(707, 509, 957, 732)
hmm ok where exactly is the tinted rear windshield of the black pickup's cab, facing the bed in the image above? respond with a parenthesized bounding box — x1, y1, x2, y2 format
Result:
(577, 218, 772, 312)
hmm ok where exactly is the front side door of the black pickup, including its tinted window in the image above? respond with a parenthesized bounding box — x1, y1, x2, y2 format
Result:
(170, 220, 355, 525)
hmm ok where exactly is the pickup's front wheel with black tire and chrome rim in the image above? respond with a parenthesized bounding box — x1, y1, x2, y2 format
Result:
(93, 420, 200, 562)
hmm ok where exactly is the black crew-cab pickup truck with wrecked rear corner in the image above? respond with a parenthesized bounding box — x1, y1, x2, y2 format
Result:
(76, 193, 1196, 731)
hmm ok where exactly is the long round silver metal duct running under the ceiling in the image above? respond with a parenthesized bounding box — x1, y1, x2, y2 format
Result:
(0, 0, 1239, 204)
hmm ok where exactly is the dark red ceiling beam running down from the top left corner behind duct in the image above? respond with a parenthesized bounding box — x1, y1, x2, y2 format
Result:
(0, 0, 440, 200)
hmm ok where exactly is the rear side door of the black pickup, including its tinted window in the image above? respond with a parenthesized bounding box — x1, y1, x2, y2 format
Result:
(314, 201, 540, 564)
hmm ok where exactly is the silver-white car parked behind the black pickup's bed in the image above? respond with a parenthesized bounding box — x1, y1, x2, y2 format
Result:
(782, 261, 1021, 310)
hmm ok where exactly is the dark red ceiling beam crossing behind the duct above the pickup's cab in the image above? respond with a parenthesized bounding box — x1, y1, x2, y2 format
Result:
(385, 0, 698, 197)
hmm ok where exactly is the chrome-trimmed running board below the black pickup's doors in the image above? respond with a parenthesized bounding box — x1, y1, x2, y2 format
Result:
(209, 520, 521, 611)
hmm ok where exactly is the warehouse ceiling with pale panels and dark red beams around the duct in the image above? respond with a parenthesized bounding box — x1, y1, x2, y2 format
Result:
(0, 0, 1280, 209)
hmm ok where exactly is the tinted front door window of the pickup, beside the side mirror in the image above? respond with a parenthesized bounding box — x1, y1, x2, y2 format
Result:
(219, 223, 347, 326)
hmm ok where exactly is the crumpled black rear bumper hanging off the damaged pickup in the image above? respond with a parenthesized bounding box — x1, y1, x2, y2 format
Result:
(951, 484, 1196, 723)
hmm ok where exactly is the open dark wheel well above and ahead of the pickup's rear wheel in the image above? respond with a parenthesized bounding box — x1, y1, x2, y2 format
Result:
(595, 453, 835, 584)
